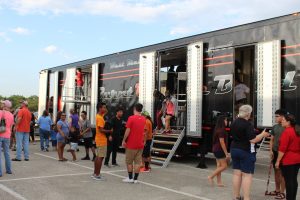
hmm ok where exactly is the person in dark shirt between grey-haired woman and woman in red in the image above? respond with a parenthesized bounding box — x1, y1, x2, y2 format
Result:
(268, 109, 286, 199)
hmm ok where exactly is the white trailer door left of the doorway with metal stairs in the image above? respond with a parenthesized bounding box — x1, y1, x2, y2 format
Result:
(139, 52, 156, 116)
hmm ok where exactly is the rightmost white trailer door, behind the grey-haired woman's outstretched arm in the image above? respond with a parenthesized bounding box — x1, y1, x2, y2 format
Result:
(257, 40, 281, 127)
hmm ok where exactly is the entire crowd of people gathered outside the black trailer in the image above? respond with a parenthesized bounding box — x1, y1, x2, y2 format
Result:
(0, 97, 300, 200)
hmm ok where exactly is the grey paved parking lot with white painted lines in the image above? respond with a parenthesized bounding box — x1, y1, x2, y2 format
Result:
(0, 144, 300, 200)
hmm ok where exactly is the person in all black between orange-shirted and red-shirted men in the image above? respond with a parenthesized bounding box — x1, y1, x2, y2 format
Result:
(104, 107, 124, 166)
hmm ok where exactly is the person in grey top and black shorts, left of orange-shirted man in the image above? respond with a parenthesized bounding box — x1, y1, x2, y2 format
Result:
(79, 111, 96, 161)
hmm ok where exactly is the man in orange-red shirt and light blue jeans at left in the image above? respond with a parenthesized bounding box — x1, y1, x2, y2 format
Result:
(12, 100, 32, 161)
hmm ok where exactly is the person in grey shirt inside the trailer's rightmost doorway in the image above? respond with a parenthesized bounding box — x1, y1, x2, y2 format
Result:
(234, 79, 250, 107)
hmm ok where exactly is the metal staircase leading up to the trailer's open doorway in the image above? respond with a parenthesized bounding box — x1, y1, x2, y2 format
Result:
(151, 127, 185, 168)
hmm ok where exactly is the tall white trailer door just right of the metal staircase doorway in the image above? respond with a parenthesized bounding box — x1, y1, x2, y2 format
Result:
(187, 42, 203, 137)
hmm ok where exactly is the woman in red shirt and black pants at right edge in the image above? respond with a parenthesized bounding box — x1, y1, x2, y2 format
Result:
(275, 114, 300, 200)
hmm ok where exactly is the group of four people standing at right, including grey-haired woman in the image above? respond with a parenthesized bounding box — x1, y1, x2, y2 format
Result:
(208, 105, 300, 200)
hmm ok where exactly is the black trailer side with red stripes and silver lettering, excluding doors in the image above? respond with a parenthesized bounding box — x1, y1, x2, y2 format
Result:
(41, 14, 300, 155)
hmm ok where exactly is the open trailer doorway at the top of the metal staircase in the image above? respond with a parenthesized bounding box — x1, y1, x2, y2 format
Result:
(155, 47, 187, 127)
